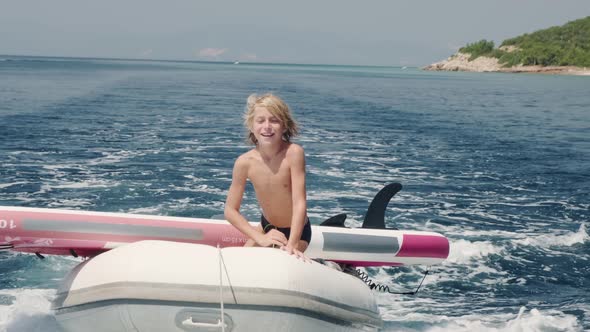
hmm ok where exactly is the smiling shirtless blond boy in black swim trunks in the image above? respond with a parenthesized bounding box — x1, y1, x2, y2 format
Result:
(224, 94, 311, 258)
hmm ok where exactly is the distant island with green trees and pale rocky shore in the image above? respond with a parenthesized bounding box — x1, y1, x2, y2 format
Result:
(422, 16, 590, 75)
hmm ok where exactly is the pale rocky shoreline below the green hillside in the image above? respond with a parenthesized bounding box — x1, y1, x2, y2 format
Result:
(422, 52, 590, 75)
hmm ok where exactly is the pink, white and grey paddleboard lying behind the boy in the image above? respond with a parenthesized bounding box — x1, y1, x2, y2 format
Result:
(0, 206, 449, 266)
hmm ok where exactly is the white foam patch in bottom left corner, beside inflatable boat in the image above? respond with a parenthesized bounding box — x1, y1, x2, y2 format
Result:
(0, 288, 59, 332)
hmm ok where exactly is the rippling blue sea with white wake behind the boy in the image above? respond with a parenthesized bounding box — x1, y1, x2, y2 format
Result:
(0, 56, 590, 332)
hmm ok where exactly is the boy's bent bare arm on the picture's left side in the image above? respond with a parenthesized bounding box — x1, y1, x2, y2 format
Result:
(224, 156, 284, 246)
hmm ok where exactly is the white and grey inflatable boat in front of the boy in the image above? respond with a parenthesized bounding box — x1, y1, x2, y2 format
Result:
(53, 241, 382, 332)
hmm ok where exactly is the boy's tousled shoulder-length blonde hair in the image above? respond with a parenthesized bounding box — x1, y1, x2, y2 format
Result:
(244, 93, 299, 145)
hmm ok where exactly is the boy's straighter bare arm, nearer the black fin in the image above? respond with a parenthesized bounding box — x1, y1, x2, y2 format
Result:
(287, 144, 307, 252)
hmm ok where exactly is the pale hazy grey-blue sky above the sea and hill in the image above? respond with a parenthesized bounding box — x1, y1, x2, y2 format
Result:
(0, 0, 590, 66)
